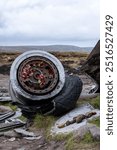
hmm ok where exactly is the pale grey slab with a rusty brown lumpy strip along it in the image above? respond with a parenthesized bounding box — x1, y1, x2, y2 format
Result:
(51, 104, 99, 134)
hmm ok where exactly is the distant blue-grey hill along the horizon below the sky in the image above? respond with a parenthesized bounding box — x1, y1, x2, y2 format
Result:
(0, 45, 93, 52)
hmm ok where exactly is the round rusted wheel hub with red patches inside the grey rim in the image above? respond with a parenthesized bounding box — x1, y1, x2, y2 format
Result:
(18, 56, 59, 94)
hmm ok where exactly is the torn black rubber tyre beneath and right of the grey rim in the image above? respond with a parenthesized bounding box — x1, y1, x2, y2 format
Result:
(12, 75, 82, 118)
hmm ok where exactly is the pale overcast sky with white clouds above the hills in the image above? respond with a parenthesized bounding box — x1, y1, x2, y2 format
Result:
(0, 0, 100, 46)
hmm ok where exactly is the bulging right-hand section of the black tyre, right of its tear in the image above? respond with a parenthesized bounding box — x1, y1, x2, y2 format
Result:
(52, 76, 82, 116)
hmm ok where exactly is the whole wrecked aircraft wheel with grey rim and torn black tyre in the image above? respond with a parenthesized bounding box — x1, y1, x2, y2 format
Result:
(9, 50, 82, 116)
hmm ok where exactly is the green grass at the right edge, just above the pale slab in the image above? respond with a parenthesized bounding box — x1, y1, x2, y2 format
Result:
(77, 96, 100, 109)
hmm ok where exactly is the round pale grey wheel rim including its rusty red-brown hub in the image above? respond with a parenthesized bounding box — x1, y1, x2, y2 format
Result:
(10, 50, 65, 102)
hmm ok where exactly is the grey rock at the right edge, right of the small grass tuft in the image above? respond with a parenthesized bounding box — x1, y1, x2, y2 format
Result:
(87, 123, 100, 141)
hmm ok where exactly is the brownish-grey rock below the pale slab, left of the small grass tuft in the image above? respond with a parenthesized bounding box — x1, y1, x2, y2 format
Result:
(73, 125, 89, 140)
